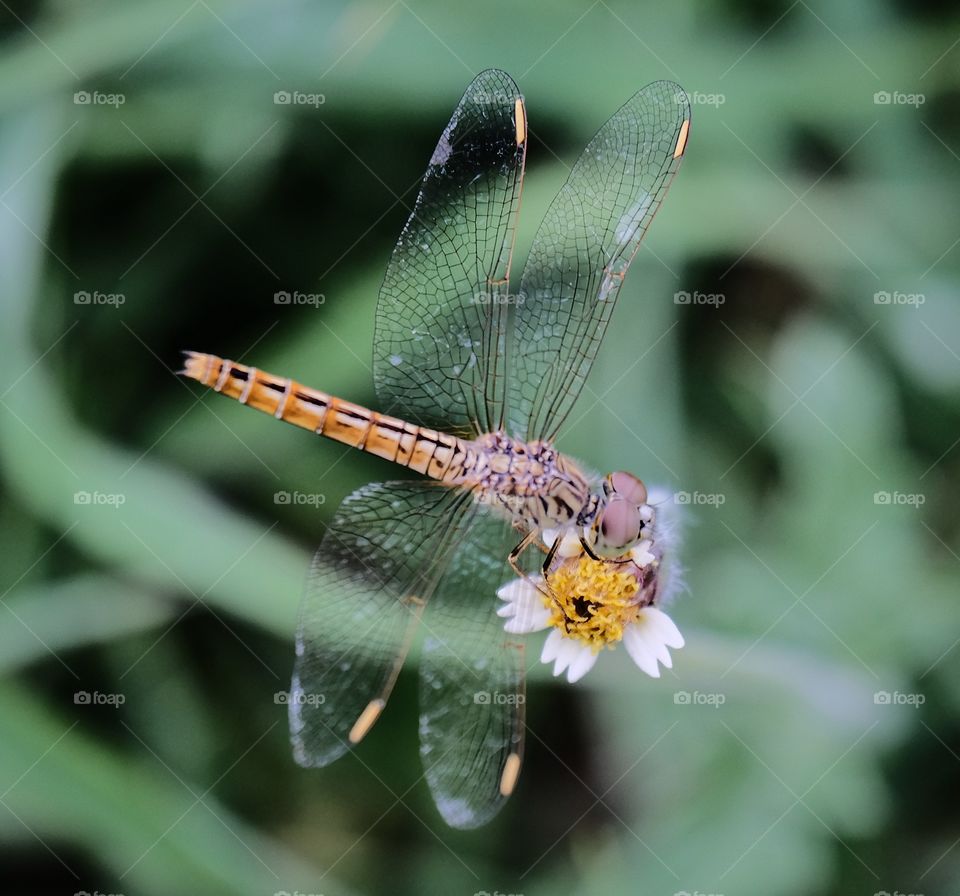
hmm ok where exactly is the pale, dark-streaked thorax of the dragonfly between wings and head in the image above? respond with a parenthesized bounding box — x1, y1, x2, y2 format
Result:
(463, 432, 594, 529)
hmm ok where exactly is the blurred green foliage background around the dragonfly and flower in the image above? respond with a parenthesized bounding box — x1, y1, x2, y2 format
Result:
(0, 0, 960, 896)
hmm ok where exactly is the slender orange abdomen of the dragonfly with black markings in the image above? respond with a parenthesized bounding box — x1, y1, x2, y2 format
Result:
(181, 352, 468, 483)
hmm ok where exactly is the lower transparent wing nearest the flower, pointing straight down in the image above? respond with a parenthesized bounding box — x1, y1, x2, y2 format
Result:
(420, 514, 532, 828)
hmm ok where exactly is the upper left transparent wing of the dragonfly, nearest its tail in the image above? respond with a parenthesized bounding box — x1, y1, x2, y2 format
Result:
(373, 69, 527, 433)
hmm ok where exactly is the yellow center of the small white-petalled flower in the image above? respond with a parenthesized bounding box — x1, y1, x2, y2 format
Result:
(544, 556, 640, 652)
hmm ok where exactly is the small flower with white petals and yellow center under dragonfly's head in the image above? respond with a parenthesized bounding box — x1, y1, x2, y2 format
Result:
(497, 531, 684, 683)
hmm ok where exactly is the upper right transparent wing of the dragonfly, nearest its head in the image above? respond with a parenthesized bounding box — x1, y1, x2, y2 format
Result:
(507, 81, 690, 440)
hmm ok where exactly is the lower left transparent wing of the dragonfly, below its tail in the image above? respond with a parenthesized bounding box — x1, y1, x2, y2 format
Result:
(289, 481, 473, 766)
